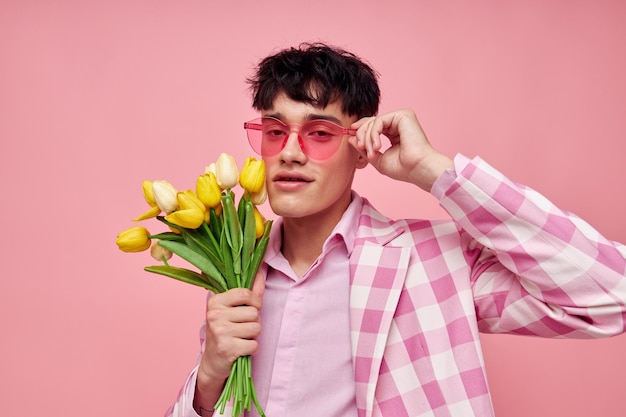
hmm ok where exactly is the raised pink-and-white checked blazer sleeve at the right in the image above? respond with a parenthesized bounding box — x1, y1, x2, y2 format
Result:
(436, 155, 626, 338)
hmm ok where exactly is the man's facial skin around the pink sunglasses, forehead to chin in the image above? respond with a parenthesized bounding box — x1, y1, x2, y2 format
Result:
(262, 94, 367, 221)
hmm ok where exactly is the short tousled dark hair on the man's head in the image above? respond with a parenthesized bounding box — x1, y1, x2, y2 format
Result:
(247, 43, 380, 118)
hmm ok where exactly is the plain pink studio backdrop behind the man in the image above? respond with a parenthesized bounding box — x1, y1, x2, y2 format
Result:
(0, 0, 626, 417)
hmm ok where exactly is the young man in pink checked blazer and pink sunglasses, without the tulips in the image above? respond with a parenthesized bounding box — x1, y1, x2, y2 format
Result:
(168, 44, 626, 417)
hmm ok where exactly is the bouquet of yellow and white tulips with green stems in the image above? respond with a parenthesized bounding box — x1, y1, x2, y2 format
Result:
(117, 153, 272, 416)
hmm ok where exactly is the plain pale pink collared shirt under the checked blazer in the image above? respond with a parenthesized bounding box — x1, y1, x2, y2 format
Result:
(250, 198, 363, 417)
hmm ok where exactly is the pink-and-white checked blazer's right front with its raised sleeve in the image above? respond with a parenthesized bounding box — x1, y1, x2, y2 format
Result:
(350, 159, 626, 417)
